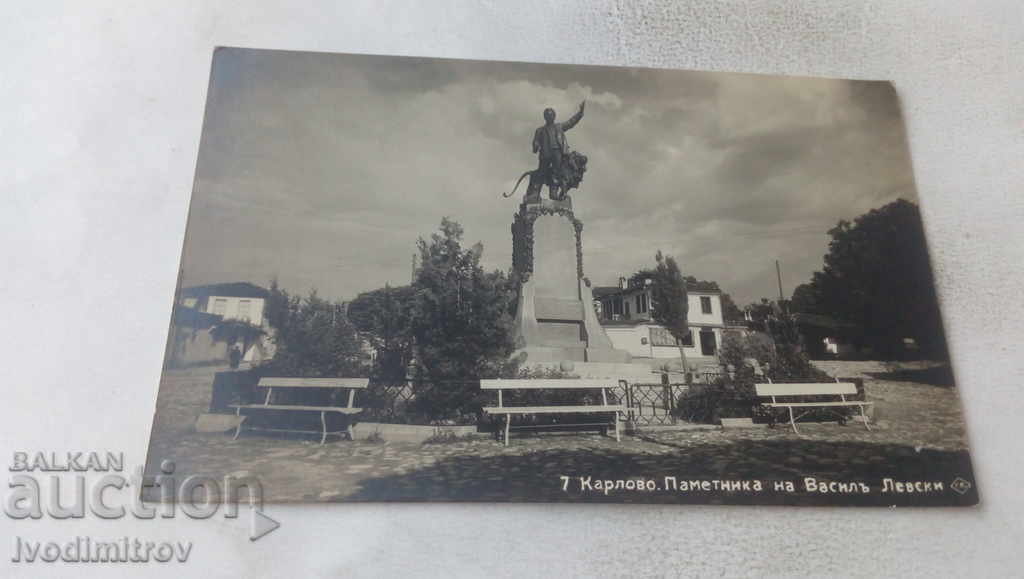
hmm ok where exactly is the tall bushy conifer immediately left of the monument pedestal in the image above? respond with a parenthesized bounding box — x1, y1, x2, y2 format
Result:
(410, 217, 515, 418)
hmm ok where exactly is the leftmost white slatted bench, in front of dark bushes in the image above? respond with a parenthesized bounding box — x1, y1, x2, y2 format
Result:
(229, 377, 370, 445)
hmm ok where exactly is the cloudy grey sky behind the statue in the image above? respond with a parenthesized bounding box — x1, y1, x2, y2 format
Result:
(182, 48, 916, 305)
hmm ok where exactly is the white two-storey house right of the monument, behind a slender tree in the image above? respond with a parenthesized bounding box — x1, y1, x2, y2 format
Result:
(594, 278, 726, 364)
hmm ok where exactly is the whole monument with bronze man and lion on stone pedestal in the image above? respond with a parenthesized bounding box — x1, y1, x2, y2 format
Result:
(505, 101, 630, 365)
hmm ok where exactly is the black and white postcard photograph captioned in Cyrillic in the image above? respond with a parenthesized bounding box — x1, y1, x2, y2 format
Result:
(146, 47, 979, 506)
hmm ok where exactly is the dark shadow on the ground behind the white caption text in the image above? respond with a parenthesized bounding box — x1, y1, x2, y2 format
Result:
(338, 440, 978, 506)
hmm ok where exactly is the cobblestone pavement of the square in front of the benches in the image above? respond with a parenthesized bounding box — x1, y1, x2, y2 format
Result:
(150, 362, 971, 504)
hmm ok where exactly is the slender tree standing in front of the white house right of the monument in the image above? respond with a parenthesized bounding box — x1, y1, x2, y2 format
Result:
(634, 250, 690, 372)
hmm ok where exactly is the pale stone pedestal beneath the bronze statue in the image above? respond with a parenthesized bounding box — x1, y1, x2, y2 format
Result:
(512, 197, 630, 365)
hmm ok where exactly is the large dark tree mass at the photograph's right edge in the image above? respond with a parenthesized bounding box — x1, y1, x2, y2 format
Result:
(800, 199, 946, 358)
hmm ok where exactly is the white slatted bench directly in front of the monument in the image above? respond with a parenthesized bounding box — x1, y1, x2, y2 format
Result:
(480, 379, 626, 446)
